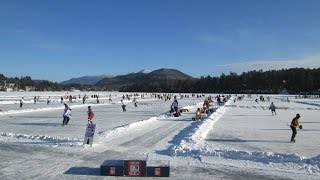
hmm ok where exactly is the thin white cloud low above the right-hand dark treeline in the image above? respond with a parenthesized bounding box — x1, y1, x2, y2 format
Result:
(217, 55, 320, 74)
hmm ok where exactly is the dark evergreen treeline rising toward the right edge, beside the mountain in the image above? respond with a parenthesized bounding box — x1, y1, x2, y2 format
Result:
(120, 68, 320, 94)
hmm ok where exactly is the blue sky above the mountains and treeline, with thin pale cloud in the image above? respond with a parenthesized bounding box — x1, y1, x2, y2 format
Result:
(0, 0, 320, 82)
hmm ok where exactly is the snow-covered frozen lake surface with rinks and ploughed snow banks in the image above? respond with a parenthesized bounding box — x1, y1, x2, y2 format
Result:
(0, 92, 320, 179)
